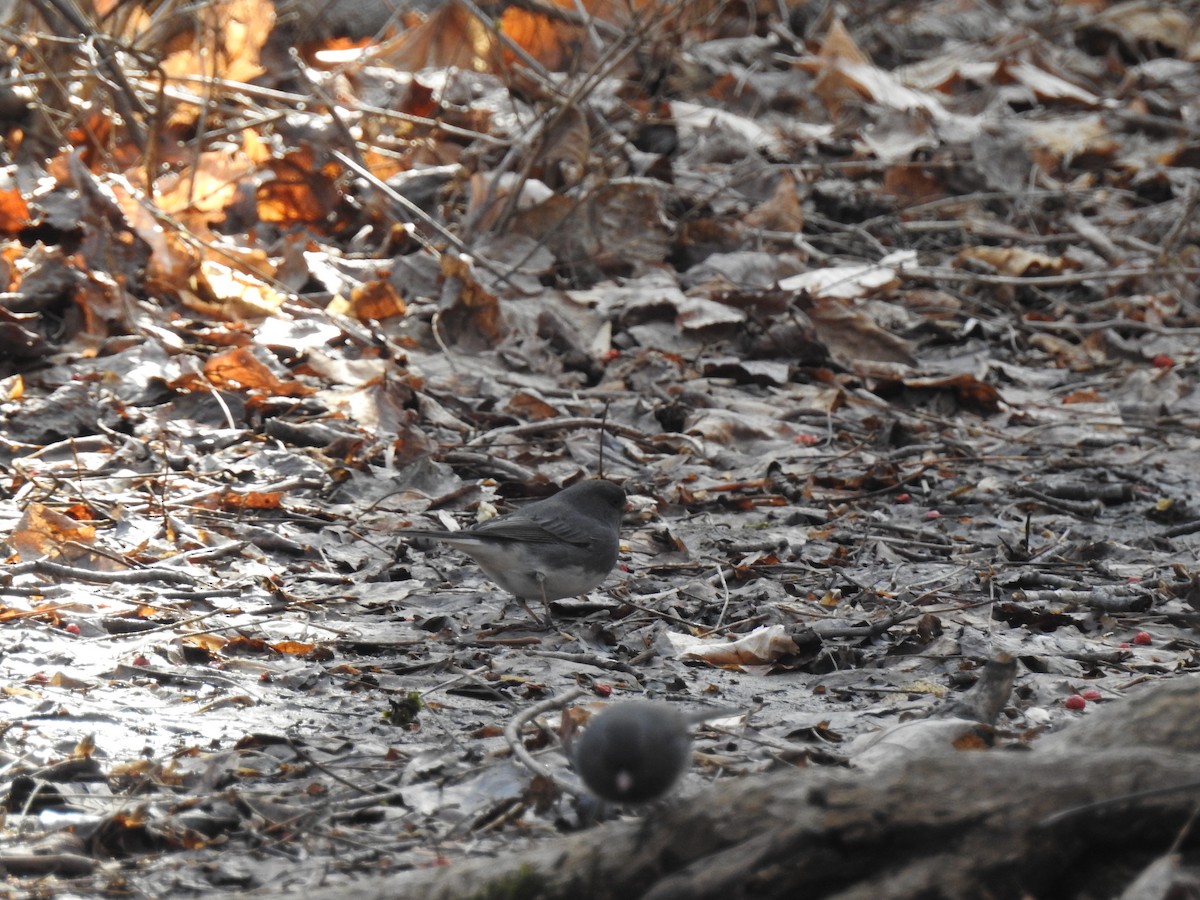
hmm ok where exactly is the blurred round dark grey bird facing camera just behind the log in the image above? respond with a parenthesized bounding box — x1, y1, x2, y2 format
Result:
(566, 700, 738, 803)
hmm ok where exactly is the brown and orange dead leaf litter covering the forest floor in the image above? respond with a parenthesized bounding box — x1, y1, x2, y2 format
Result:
(0, 0, 1200, 896)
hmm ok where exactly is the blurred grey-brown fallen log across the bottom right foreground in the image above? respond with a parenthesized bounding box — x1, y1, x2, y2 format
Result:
(258, 676, 1200, 900)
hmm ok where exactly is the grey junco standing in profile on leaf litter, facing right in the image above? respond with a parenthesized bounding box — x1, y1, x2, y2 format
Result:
(404, 480, 625, 619)
